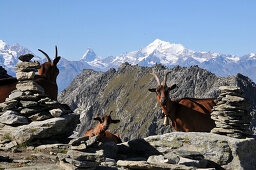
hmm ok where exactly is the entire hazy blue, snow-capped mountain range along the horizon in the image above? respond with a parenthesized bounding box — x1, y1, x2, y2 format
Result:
(0, 39, 256, 91)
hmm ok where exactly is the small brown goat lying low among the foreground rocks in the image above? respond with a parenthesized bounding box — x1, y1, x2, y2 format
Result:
(84, 111, 122, 143)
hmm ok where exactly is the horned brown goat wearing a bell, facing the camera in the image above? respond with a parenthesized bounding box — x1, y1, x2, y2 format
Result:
(148, 72, 216, 132)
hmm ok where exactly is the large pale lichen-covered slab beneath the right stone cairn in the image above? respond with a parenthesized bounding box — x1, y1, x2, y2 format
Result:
(144, 132, 256, 169)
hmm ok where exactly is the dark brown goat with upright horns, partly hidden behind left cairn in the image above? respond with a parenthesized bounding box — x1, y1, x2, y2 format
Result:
(0, 46, 61, 103)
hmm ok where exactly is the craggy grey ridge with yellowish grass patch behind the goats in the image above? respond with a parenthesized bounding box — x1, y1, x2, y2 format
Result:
(58, 63, 256, 141)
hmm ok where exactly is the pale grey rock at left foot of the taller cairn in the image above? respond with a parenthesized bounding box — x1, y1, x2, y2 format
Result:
(0, 110, 28, 125)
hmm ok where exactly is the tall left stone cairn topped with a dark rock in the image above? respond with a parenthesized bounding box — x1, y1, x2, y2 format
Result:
(0, 54, 72, 126)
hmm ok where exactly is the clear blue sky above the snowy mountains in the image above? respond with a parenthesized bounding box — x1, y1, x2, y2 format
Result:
(0, 0, 256, 60)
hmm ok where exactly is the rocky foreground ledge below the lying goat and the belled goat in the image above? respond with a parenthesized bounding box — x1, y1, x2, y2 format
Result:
(58, 132, 256, 170)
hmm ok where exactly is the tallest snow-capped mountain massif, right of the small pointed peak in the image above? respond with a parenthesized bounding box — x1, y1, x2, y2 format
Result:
(82, 39, 250, 70)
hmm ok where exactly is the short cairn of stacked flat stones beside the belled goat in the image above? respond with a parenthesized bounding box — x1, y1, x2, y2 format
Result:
(211, 86, 252, 138)
